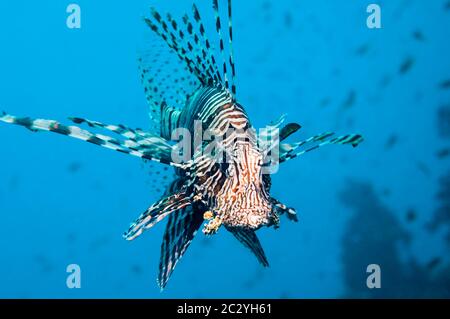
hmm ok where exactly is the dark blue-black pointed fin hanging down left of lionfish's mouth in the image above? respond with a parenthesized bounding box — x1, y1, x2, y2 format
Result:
(158, 206, 203, 290)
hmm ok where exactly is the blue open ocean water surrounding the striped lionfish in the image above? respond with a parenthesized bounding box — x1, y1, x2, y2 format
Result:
(0, 0, 450, 298)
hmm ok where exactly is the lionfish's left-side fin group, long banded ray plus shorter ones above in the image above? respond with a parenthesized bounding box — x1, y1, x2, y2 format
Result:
(0, 112, 182, 167)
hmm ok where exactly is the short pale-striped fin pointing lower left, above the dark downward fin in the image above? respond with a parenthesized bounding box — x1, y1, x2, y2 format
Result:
(123, 192, 191, 240)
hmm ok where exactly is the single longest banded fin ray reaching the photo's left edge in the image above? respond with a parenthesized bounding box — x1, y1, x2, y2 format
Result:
(0, 113, 182, 167)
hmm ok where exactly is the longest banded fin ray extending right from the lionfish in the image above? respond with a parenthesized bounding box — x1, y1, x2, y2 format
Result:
(279, 132, 364, 163)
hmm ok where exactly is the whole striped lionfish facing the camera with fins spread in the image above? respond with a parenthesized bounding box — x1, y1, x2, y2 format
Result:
(0, 0, 363, 289)
